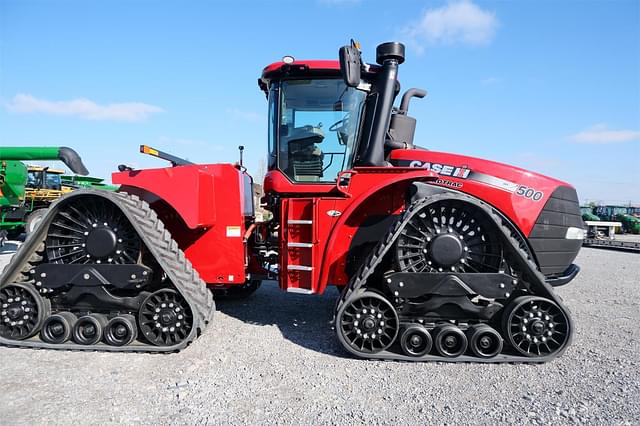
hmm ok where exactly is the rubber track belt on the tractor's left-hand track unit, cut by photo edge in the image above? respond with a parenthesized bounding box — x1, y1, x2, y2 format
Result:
(0, 190, 215, 353)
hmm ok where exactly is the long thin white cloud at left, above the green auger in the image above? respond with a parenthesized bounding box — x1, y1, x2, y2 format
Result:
(7, 93, 164, 122)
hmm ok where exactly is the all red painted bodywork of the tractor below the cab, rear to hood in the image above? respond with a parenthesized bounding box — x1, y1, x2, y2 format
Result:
(113, 150, 569, 293)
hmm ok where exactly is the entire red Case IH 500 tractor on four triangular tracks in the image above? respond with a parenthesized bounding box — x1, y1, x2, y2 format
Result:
(0, 43, 583, 362)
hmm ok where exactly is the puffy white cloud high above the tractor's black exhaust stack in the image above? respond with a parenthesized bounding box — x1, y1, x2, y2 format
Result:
(403, 0, 499, 51)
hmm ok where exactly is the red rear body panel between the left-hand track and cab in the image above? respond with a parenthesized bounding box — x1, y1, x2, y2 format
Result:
(112, 164, 246, 284)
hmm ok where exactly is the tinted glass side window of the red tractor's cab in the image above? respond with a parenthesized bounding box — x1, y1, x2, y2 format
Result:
(271, 79, 366, 182)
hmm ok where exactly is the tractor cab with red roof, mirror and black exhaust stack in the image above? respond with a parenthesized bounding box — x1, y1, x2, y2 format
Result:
(258, 43, 426, 192)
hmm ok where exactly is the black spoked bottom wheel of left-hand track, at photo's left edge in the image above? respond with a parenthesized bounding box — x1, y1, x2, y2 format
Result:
(0, 283, 49, 340)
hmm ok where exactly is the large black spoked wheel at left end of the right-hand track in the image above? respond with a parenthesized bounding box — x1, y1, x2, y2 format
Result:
(336, 291, 399, 356)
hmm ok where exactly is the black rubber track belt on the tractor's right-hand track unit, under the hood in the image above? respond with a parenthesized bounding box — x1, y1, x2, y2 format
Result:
(333, 192, 574, 363)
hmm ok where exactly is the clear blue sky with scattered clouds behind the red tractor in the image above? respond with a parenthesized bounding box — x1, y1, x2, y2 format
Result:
(0, 0, 640, 203)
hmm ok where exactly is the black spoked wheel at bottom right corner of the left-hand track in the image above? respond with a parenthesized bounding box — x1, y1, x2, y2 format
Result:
(138, 289, 193, 346)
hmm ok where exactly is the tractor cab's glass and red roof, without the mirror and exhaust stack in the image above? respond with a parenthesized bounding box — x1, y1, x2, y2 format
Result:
(261, 61, 366, 184)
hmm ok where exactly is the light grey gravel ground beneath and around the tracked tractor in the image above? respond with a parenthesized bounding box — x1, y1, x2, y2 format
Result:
(0, 241, 640, 424)
